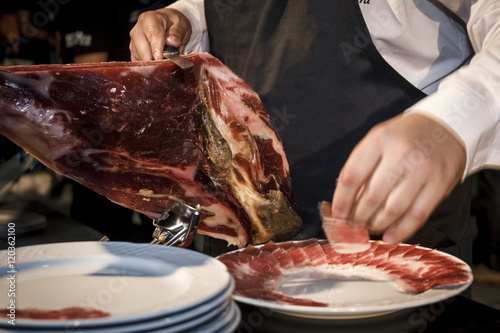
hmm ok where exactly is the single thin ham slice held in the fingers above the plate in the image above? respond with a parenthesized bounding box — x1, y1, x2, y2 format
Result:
(318, 201, 370, 253)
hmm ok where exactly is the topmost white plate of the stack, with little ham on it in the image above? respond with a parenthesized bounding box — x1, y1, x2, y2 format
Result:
(0, 242, 232, 328)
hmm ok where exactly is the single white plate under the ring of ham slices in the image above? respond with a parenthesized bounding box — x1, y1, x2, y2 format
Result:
(225, 240, 473, 319)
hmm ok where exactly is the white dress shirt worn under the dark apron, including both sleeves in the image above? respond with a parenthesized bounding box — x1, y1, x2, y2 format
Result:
(170, 0, 500, 178)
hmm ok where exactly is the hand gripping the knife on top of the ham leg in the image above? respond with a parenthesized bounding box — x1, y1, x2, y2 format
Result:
(129, 8, 191, 61)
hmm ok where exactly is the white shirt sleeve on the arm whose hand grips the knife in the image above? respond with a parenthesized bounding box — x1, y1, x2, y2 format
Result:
(168, 0, 209, 54)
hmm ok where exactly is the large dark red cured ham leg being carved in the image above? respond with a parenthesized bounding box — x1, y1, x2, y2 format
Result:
(0, 54, 302, 247)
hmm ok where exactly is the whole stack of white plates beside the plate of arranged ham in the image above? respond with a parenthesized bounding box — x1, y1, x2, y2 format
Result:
(0, 242, 241, 333)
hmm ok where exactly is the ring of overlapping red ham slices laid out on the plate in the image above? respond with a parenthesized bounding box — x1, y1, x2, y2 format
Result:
(219, 239, 472, 307)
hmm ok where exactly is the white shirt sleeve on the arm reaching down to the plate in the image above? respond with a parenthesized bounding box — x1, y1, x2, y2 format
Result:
(408, 0, 500, 178)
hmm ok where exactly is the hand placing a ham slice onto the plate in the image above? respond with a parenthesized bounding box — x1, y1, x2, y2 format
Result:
(332, 113, 466, 243)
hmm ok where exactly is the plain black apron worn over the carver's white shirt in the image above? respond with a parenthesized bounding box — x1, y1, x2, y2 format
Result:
(205, 0, 471, 260)
